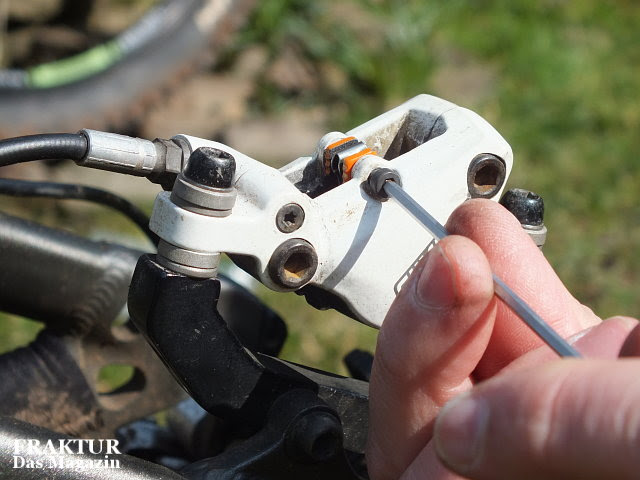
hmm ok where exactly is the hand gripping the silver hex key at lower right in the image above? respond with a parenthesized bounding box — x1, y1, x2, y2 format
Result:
(367, 200, 640, 480)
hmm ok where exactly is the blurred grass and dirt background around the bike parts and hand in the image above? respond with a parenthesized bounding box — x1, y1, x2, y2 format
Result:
(0, 0, 640, 373)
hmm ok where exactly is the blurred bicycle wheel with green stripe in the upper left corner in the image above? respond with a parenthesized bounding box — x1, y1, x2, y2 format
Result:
(0, 0, 255, 137)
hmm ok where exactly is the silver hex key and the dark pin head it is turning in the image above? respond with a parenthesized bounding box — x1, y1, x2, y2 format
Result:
(367, 168, 581, 358)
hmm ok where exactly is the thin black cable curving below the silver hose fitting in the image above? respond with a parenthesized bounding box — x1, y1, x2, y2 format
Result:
(0, 178, 159, 246)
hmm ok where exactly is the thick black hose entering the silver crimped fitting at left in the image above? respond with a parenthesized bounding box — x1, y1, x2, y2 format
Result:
(0, 133, 89, 167)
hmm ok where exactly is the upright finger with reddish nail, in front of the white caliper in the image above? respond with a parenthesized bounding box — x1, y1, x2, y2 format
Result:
(367, 235, 496, 479)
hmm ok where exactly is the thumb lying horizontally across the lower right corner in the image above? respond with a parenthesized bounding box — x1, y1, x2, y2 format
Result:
(434, 359, 640, 479)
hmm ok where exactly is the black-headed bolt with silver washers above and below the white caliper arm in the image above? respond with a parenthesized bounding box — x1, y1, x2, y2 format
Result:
(157, 147, 237, 278)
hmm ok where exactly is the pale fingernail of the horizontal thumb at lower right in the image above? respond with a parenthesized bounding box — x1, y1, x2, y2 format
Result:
(434, 394, 489, 471)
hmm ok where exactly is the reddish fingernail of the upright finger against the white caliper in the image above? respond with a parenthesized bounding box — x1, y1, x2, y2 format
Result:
(416, 245, 456, 308)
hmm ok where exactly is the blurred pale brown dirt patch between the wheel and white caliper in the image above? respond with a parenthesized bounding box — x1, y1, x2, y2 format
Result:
(141, 47, 328, 167)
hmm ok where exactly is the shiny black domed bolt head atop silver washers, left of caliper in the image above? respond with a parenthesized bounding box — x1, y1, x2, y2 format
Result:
(183, 147, 236, 188)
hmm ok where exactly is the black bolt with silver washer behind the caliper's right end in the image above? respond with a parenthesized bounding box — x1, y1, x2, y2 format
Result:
(500, 188, 547, 248)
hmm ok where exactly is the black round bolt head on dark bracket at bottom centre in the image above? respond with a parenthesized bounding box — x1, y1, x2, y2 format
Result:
(285, 411, 343, 463)
